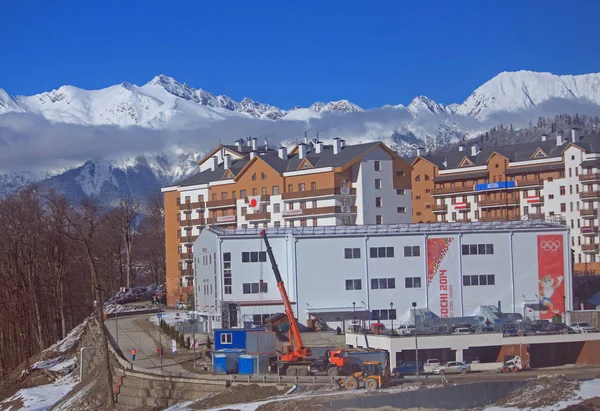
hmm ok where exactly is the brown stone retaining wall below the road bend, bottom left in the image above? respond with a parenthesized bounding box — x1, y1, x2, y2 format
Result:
(114, 370, 228, 410)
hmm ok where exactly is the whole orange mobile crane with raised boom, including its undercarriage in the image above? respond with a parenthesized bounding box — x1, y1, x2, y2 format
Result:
(260, 230, 315, 376)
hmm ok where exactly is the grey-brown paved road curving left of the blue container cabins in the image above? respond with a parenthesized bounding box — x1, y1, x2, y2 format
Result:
(106, 314, 189, 373)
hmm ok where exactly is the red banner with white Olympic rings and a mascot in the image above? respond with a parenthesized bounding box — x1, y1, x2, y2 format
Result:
(537, 235, 565, 320)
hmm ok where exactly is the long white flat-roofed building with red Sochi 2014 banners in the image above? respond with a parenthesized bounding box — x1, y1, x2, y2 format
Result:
(193, 220, 572, 328)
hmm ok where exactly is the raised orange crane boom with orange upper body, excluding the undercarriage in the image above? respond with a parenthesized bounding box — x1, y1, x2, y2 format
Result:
(260, 230, 312, 362)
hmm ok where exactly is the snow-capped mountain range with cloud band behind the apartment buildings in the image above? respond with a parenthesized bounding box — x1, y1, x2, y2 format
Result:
(0, 71, 600, 203)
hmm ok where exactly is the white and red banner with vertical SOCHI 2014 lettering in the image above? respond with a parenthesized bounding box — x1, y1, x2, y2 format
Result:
(427, 237, 462, 318)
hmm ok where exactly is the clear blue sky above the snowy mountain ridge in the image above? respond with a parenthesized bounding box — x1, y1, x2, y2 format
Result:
(0, 0, 600, 108)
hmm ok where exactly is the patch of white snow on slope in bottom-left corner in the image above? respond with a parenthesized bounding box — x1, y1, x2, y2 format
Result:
(0, 376, 77, 411)
